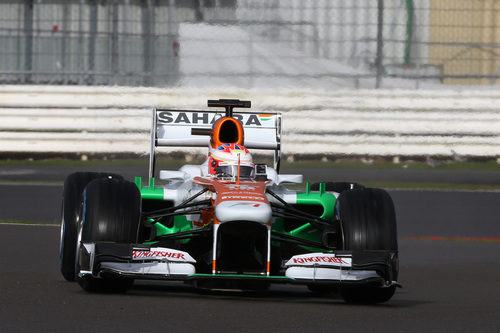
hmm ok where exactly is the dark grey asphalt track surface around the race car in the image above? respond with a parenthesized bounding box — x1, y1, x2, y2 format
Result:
(0, 167, 500, 332)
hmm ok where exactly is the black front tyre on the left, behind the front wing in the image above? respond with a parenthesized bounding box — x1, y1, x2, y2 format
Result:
(77, 178, 141, 292)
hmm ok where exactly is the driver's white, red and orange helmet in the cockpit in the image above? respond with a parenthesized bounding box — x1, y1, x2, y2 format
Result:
(208, 143, 254, 178)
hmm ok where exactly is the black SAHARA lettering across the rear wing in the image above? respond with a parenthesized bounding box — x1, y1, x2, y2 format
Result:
(157, 111, 274, 127)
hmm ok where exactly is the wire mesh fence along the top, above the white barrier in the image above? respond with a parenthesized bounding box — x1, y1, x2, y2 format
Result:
(0, 0, 500, 88)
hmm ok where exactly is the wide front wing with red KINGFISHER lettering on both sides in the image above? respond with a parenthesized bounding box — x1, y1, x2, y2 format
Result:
(79, 242, 396, 287)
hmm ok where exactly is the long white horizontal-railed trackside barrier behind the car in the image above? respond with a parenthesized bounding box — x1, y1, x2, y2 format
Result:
(0, 86, 500, 160)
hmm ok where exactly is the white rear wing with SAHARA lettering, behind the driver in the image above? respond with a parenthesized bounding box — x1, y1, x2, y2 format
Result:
(149, 105, 281, 178)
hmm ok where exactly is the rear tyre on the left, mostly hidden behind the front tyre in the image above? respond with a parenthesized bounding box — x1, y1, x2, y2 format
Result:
(59, 172, 122, 281)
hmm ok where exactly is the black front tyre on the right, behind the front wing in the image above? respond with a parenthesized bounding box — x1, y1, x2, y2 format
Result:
(336, 188, 398, 303)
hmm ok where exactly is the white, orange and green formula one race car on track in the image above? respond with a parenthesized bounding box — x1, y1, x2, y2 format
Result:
(60, 100, 399, 303)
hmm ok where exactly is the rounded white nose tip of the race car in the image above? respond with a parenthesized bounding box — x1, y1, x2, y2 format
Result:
(215, 201, 272, 224)
